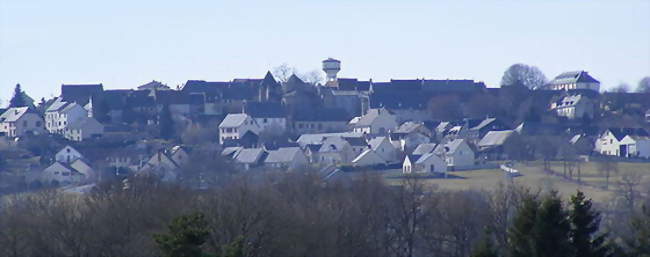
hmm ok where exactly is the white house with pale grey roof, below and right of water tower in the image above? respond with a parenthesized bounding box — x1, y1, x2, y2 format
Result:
(349, 108, 399, 135)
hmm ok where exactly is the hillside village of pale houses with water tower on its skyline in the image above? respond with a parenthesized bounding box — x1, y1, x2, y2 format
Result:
(0, 58, 650, 191)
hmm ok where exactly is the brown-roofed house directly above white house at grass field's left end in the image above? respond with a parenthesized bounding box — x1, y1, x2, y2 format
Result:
(390, 121, 433, 153)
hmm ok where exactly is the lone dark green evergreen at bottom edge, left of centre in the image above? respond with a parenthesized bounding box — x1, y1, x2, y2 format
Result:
(154, 213, 210, 257)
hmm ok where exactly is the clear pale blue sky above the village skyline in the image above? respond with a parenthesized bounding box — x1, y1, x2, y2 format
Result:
(0, 0, 650, 103)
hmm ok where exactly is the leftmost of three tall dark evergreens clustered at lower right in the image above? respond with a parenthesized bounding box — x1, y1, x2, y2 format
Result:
(508, 195, 539, 257)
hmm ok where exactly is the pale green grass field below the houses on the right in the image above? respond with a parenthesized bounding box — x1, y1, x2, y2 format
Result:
(384, 162, 650, 201)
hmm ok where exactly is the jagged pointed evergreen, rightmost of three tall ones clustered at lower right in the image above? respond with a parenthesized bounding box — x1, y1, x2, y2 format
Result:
(569, 191, 609, 257)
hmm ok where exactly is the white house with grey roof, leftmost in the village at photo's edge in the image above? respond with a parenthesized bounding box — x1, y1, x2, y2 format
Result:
(0, 107, 45, 137)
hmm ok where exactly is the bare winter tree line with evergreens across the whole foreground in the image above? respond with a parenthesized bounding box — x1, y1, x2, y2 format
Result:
(0, 173, 650, 257)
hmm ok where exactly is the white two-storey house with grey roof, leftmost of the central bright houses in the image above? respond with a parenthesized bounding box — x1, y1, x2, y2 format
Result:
(219, 113, 262, 144)
